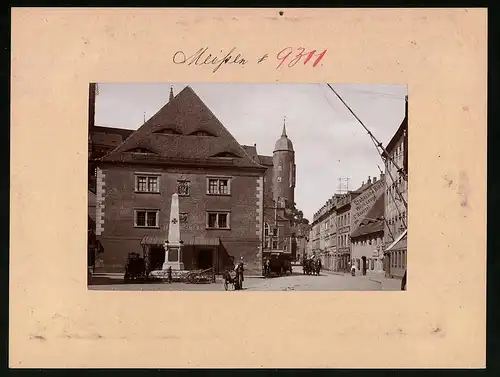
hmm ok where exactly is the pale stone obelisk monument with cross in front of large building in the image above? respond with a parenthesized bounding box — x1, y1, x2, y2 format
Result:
(162, 193, 184, 270)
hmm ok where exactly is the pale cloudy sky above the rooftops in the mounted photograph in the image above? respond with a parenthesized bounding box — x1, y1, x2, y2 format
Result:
(95, 83, 407, 221)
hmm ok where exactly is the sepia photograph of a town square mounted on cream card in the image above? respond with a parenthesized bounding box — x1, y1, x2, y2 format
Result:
(87, 83, 408, 291)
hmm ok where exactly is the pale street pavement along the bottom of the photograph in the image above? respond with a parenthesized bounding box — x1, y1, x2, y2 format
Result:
(89, 266, 401, 291)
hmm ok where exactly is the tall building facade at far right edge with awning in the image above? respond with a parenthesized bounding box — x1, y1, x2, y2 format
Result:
(383, 98, 408, 277)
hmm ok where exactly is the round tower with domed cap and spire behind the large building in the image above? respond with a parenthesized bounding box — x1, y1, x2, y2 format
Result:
(273, 117, 295, 208)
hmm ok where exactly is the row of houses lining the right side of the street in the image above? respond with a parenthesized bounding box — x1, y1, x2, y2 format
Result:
(307, 100, 408, 277)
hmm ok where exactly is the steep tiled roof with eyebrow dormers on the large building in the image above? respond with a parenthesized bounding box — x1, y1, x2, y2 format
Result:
(101, 86, 263, 168)
